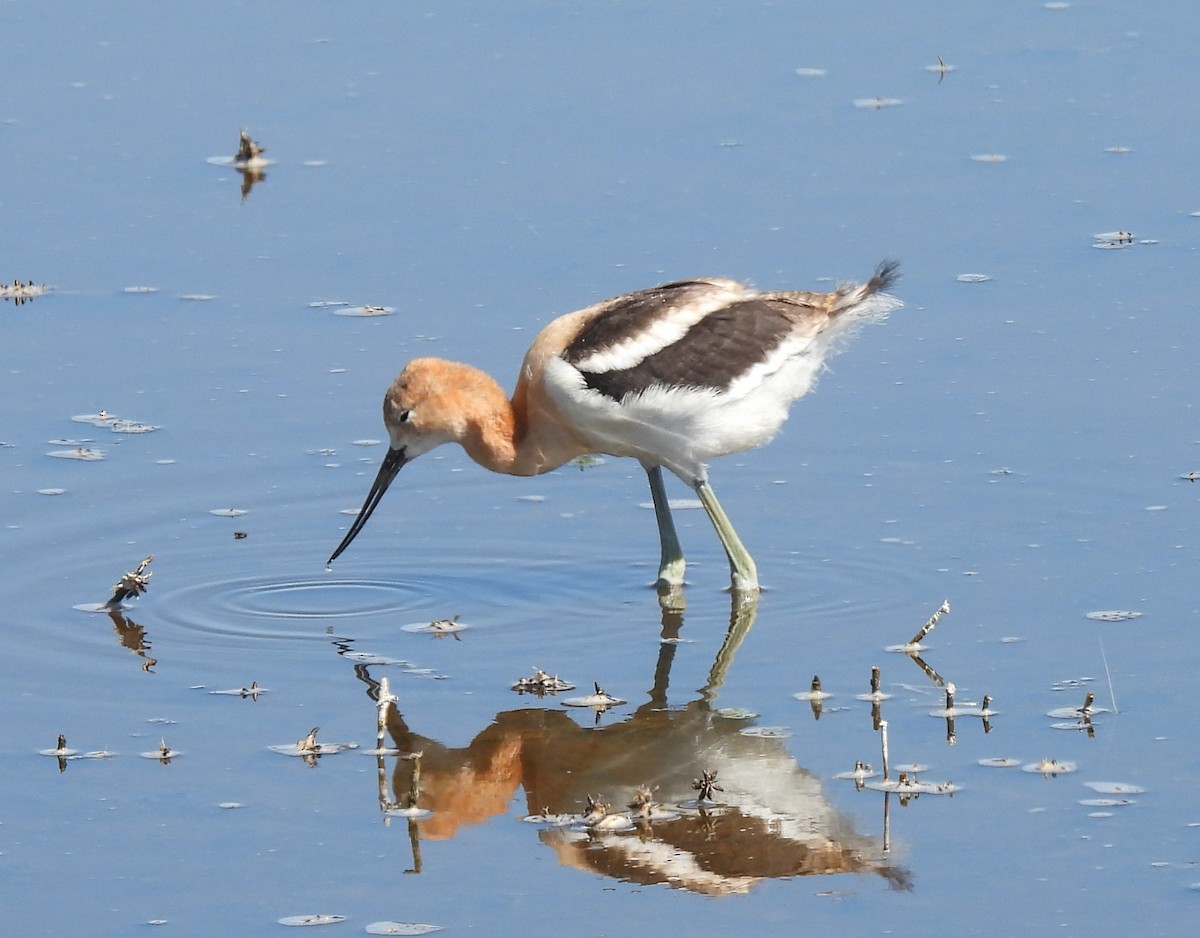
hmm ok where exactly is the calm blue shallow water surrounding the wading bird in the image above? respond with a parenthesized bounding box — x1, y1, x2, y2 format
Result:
(0, 1, 1200, 936)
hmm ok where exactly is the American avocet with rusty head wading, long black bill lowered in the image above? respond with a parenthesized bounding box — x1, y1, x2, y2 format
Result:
(329, 261, 901, 593)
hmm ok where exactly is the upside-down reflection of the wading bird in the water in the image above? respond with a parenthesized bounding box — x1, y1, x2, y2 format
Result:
(356, 596, 910, 896)
